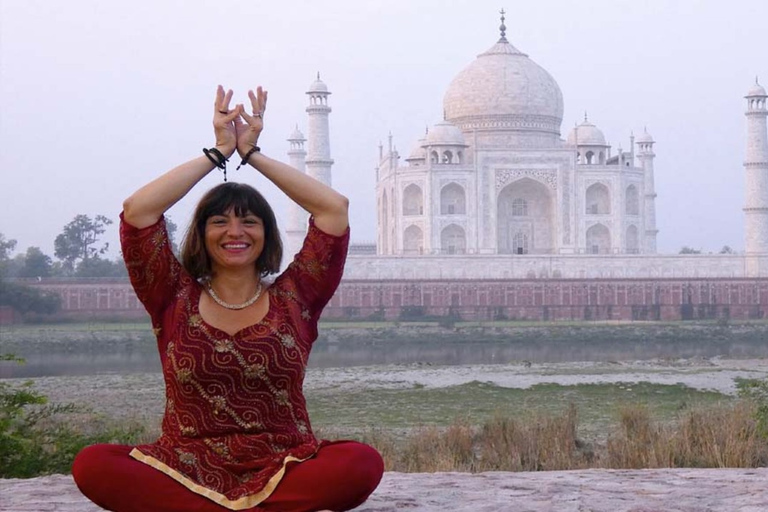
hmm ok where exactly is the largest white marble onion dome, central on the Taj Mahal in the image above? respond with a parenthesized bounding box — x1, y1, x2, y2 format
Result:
(443, 37, 563, 136)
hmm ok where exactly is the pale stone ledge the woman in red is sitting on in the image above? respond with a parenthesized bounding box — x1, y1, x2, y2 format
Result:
(0, 468, 768, 512)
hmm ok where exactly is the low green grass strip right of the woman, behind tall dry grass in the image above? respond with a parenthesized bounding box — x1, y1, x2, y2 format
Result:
(307, 382, 733, 434)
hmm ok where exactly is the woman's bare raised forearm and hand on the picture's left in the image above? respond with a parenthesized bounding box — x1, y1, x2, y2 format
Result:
(123, 86, 242, 228)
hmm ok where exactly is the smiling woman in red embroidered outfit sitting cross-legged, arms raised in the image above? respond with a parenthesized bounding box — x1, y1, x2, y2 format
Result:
(72, 86, 383, 512)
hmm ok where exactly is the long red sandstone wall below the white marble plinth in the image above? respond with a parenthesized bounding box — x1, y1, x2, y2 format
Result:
(16, 279, 768, 321)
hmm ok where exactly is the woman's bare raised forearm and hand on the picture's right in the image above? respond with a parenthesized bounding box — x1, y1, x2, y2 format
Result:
(234, 87, 349, 235)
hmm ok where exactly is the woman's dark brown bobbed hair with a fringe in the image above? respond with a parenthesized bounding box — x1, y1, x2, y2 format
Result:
(181, 182, 283, 279)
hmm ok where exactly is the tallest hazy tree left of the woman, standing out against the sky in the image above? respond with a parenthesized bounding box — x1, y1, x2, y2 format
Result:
(54, 214, 112, 272)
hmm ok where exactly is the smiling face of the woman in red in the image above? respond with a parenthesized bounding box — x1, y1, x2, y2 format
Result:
(205, 208, 264, 272)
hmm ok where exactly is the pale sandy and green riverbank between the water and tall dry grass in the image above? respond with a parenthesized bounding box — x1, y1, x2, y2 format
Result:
(3, 358, 768, 438)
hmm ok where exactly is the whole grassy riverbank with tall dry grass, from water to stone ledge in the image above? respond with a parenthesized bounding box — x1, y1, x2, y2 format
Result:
(0, 361, 768, 471)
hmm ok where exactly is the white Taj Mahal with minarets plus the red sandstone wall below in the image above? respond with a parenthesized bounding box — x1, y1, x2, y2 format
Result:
(21, 12, 768, 321)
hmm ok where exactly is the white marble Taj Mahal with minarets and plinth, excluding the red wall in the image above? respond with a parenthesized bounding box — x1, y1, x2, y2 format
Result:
(286, 11, 768, 279)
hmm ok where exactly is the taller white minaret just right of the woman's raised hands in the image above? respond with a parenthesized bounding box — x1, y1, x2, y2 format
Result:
(307, 73, 333, 187)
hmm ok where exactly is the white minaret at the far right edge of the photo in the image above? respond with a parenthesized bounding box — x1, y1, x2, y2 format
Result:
(744, 79, 768, 268)
